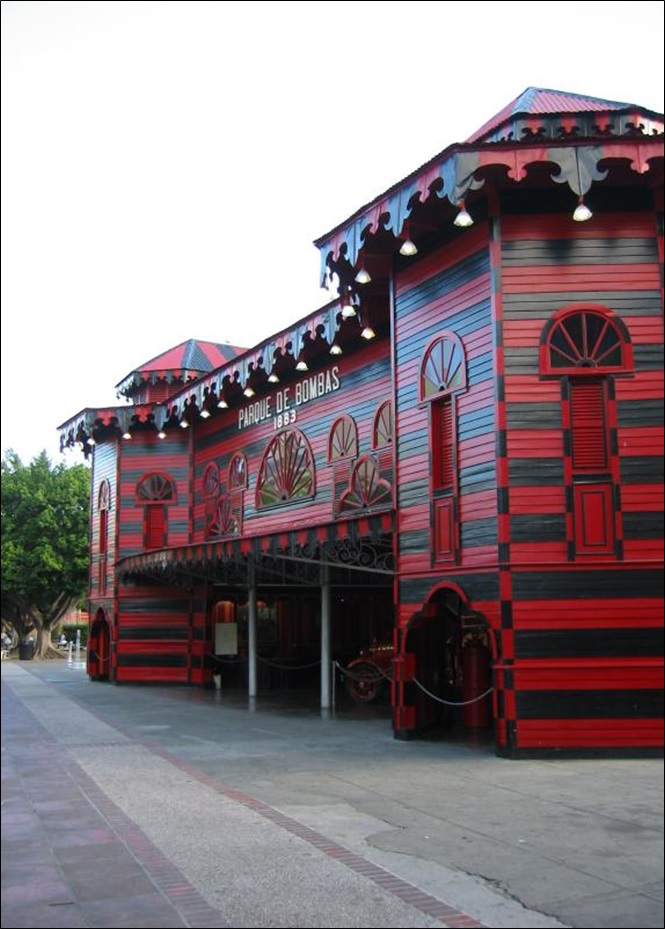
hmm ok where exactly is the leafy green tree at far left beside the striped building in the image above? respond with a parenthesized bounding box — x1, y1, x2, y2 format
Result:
(1, 449, 90, 656)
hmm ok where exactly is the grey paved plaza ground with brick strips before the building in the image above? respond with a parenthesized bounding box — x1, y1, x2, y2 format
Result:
(2, 660, 663, 929)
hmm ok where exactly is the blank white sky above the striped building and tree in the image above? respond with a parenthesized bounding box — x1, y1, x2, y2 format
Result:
(1, 0, 664, 463)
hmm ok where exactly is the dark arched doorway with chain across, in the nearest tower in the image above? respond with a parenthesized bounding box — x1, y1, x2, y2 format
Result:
(402, 585, 492, 737)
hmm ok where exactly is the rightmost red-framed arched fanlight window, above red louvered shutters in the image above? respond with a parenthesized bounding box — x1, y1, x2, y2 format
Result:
(540, 304, 633, 377)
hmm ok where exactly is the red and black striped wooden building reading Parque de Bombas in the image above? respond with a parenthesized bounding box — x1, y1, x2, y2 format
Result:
(60, 88, 663, 756)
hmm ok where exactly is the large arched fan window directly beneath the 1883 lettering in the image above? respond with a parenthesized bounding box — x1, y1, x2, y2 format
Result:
(256, 429, 314, 507)
